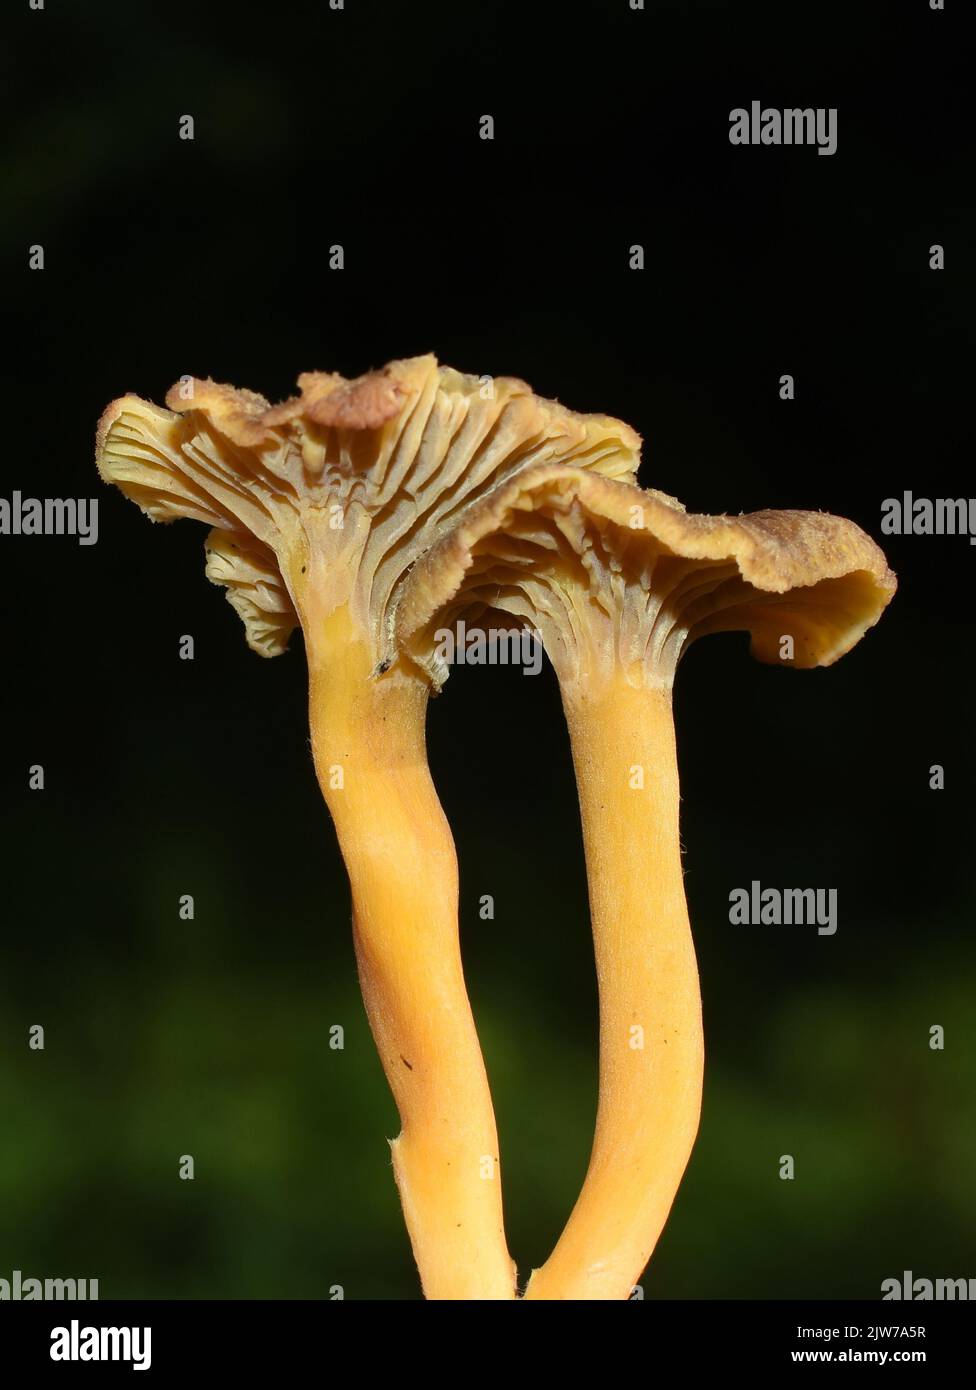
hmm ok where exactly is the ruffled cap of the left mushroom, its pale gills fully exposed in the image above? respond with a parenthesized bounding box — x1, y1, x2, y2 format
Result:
(96, 356, 641, 662)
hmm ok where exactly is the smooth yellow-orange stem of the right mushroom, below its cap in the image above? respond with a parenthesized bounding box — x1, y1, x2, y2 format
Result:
(526, 677, 703, 1300)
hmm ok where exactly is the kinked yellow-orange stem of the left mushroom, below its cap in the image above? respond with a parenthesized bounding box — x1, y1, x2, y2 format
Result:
(303, 607, 516, 1300)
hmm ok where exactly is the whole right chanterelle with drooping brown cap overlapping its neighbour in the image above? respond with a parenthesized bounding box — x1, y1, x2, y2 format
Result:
(396, 466, 895, 1298)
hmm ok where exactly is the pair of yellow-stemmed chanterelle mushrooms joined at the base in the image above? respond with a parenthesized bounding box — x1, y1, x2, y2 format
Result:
(97, 356, 895, 1300)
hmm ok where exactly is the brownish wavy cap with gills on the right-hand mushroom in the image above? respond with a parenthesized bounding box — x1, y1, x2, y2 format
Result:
(396, 464, 895, 685)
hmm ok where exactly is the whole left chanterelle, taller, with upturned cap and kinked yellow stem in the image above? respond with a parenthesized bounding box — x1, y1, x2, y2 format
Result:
(97, 357, 638, 1298)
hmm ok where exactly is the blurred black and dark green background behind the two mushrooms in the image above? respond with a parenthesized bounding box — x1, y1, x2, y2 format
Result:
(0, 0, 976, 1298)
